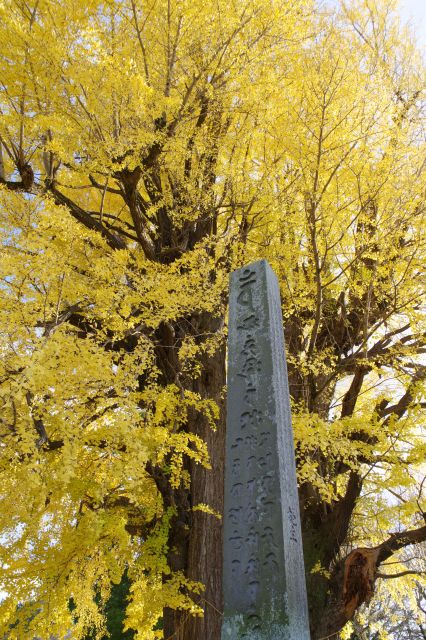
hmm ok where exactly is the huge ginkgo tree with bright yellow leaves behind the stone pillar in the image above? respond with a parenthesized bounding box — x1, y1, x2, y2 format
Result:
(0, 0, 426, 640)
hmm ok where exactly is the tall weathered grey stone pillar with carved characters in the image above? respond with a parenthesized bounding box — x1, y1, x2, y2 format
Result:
(222, 260, 310, 640)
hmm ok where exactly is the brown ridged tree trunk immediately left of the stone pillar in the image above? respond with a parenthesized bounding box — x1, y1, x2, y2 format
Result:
(164, 316, 226, 640)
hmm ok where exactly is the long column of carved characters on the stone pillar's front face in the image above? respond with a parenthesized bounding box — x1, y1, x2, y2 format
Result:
(227, 268, 279, 630)
